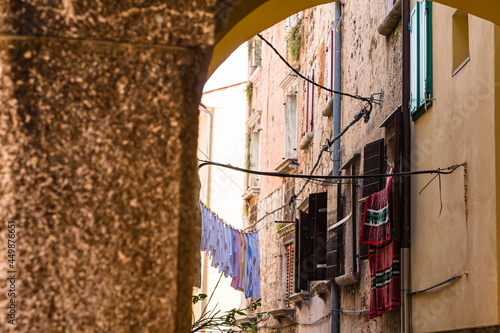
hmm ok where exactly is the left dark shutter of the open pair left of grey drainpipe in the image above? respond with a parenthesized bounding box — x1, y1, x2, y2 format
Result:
(295, 211, 314, 293)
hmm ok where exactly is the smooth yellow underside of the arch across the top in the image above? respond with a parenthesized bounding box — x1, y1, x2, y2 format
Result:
(208, 0, 500, 76)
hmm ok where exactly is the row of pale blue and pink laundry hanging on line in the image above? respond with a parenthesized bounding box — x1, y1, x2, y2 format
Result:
(200, 201, 261, 300)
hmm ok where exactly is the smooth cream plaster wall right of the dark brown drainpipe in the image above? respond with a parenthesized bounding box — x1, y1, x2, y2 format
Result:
(411, 4, 498, 332)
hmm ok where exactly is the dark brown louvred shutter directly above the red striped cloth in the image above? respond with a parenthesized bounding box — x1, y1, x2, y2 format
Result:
(363, 139, 385, 197)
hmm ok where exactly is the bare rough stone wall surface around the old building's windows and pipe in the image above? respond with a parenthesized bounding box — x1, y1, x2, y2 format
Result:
(246, 0, 401, 332)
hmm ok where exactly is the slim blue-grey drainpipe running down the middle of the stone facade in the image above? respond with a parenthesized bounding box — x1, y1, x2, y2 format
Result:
(331, 2, 342, 333)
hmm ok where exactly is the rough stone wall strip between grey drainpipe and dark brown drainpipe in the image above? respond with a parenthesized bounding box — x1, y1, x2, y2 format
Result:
(340, 0, 402, 332)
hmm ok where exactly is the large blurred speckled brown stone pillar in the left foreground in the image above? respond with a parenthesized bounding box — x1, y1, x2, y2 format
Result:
(0, 0, 229, 332)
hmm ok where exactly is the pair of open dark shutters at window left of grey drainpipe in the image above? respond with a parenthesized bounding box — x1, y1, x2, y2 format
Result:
(294, 192, 327, 293)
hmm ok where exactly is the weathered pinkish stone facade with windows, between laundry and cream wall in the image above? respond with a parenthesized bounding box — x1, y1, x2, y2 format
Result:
(244, 1, 401, 332)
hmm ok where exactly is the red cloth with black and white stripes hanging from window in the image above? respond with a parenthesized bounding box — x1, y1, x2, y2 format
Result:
(359, 177, 401, 319)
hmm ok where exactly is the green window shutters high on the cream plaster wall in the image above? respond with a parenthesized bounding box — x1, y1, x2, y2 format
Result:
(409, 0, 432, 120)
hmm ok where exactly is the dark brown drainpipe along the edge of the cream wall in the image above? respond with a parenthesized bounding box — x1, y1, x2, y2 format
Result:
(399, 0, 411, 333)
